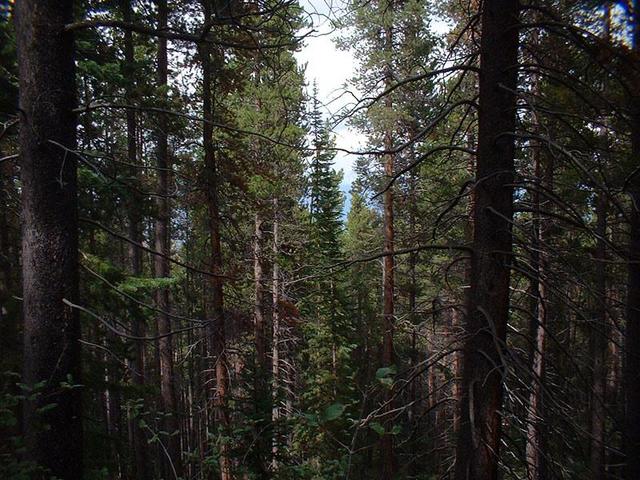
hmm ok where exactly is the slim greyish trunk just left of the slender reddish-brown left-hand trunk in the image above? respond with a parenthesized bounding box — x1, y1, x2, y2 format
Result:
(155, 0, 182, 478)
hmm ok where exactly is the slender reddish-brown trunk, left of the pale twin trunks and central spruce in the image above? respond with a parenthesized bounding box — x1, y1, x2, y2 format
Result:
(200, 0, 232, 480)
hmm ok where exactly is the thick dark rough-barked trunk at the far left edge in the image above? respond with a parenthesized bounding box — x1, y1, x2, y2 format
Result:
(16, 0, 83, 480)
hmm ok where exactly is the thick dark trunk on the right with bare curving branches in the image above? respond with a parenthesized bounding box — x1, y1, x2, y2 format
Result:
(455, 0, 519, 480)
